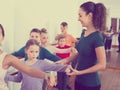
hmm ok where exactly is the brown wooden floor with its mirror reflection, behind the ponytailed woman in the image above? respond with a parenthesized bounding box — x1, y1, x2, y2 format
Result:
(49, 48, 120, 90)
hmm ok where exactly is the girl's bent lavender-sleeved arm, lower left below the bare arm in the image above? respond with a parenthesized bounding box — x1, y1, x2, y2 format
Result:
(5, 72, 23, 82)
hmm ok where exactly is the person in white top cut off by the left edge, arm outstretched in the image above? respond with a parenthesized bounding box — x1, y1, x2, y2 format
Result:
(0, 24, 45, 90)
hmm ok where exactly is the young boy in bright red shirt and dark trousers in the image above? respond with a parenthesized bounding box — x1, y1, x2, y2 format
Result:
(56, 34, 76, 90)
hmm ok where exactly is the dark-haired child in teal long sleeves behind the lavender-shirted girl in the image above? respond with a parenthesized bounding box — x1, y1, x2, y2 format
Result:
(12, 28, 60, 61)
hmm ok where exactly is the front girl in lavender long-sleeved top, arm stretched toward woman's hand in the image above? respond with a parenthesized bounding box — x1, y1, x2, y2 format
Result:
(5, 39, 67, 90)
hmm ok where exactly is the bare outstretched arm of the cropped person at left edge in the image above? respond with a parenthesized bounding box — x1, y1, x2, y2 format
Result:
(3, 54, 46, 79)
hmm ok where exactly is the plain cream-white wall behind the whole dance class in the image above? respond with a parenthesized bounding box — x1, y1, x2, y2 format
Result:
(0, 0, 120, 52)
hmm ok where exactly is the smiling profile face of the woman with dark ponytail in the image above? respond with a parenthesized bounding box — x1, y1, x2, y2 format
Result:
(78, 8, 92, 27)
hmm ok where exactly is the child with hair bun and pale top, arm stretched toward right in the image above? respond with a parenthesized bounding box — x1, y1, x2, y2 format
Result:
(40, 28, 71, 89)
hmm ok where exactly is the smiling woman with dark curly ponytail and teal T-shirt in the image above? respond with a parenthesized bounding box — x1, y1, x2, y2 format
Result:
(57, 2, 106, 90)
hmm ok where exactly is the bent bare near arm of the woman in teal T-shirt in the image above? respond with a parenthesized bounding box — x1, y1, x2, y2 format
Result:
(68, 46, 106, 75)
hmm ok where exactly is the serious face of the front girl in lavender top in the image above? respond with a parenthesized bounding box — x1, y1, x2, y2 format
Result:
(25, 45, 39, 60)
